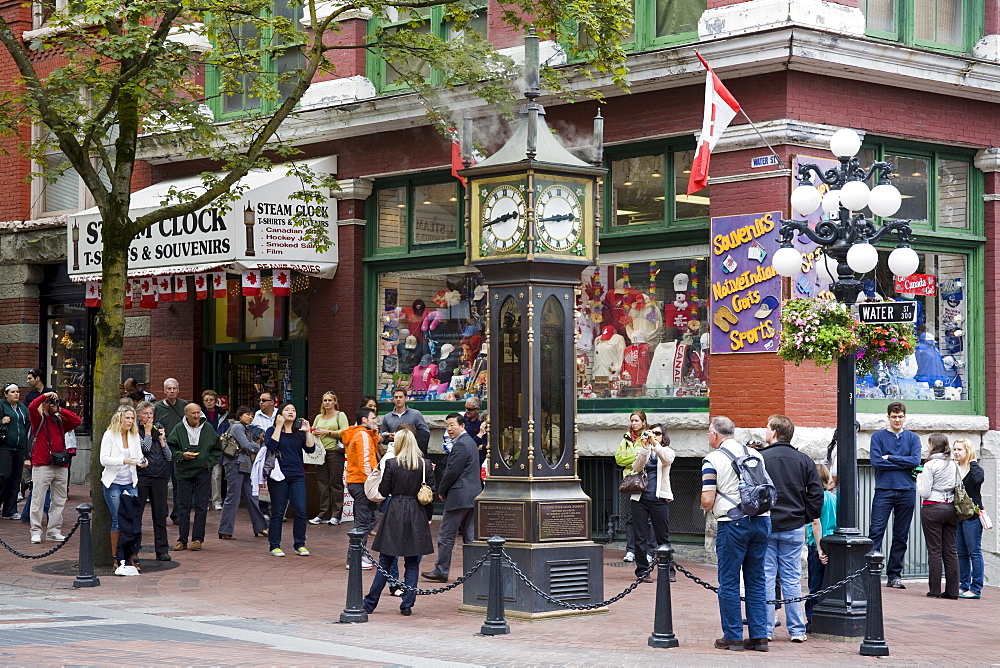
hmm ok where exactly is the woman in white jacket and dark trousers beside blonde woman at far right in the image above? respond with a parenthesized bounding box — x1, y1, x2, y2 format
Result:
(917, 434, 962, 599)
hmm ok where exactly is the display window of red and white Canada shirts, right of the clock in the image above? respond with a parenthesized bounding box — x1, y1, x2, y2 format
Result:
(576, 257, 709, 398)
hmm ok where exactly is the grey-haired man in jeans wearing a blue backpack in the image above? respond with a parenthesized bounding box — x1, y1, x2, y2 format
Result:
(701, 415, 775, 652)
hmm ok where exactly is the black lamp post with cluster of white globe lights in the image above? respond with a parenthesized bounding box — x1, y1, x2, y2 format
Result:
(773, 129, 919, 638)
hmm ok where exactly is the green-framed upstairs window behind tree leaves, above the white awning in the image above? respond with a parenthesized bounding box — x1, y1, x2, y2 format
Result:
(205, 0, 305, 121)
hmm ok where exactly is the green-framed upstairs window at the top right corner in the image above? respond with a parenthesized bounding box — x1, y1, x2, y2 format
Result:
(858, 0, 985, 53)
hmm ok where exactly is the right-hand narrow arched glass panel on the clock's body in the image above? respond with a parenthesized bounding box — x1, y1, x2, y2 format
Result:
(539, 295, 568, 466)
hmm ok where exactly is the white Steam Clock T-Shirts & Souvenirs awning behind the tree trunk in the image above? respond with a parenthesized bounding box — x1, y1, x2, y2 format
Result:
(67, 156, 338, 281)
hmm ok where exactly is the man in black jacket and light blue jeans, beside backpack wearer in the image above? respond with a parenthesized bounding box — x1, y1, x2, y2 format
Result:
(760, 415, 823, 642)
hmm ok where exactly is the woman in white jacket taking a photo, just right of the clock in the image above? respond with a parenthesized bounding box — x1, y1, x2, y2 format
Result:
(631, 424, 677, 582)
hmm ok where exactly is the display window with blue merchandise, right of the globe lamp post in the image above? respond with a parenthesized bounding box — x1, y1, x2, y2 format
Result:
(857, 249, 970, 401)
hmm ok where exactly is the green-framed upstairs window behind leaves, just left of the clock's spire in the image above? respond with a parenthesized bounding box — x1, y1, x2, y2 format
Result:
(365, 3, 487, 94)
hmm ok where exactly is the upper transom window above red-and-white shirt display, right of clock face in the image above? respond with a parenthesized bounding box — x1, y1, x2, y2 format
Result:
(601, 142, 711, 238)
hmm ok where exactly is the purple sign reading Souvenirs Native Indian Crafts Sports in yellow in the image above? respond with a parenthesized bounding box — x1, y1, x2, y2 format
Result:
(709, 211, 781, 354)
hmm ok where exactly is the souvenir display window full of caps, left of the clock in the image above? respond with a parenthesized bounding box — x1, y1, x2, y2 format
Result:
(376, 267, 486, 401)
